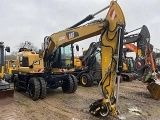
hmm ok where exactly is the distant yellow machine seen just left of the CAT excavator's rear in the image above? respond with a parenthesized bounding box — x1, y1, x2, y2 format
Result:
(4, 59, 17, 83)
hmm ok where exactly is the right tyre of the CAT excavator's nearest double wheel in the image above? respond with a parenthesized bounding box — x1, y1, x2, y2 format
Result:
(38, 77, 47, 99)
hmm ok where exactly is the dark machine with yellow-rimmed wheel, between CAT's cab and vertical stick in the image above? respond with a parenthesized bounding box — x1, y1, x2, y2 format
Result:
(72, 42, 102, 87)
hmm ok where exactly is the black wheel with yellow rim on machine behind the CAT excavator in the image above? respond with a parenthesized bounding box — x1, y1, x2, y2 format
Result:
(80, 73, 93, 87)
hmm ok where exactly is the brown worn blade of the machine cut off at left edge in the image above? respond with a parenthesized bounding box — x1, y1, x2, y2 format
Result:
(0, 80, 14, 105)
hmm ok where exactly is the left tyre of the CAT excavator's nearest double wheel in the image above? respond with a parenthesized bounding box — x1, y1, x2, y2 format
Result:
(28, 77, 40, 101)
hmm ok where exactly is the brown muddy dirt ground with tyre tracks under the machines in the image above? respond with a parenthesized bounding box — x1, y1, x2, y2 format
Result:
(0, 81, 160, 120)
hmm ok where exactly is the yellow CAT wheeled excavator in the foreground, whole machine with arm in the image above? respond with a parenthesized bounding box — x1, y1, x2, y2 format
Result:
(15, 1, 125, 116)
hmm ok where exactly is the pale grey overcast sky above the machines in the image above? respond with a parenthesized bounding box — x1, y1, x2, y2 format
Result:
(0, 0, 160, 51)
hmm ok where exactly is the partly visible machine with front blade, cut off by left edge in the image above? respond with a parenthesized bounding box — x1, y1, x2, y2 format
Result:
(0, 42, 14, 101)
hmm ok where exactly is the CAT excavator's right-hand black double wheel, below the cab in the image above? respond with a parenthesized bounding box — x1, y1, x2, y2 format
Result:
(62, 75, 77, 93)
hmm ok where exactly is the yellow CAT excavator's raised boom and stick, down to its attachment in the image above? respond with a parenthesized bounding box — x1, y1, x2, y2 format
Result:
(43, 1, 125, 116)
